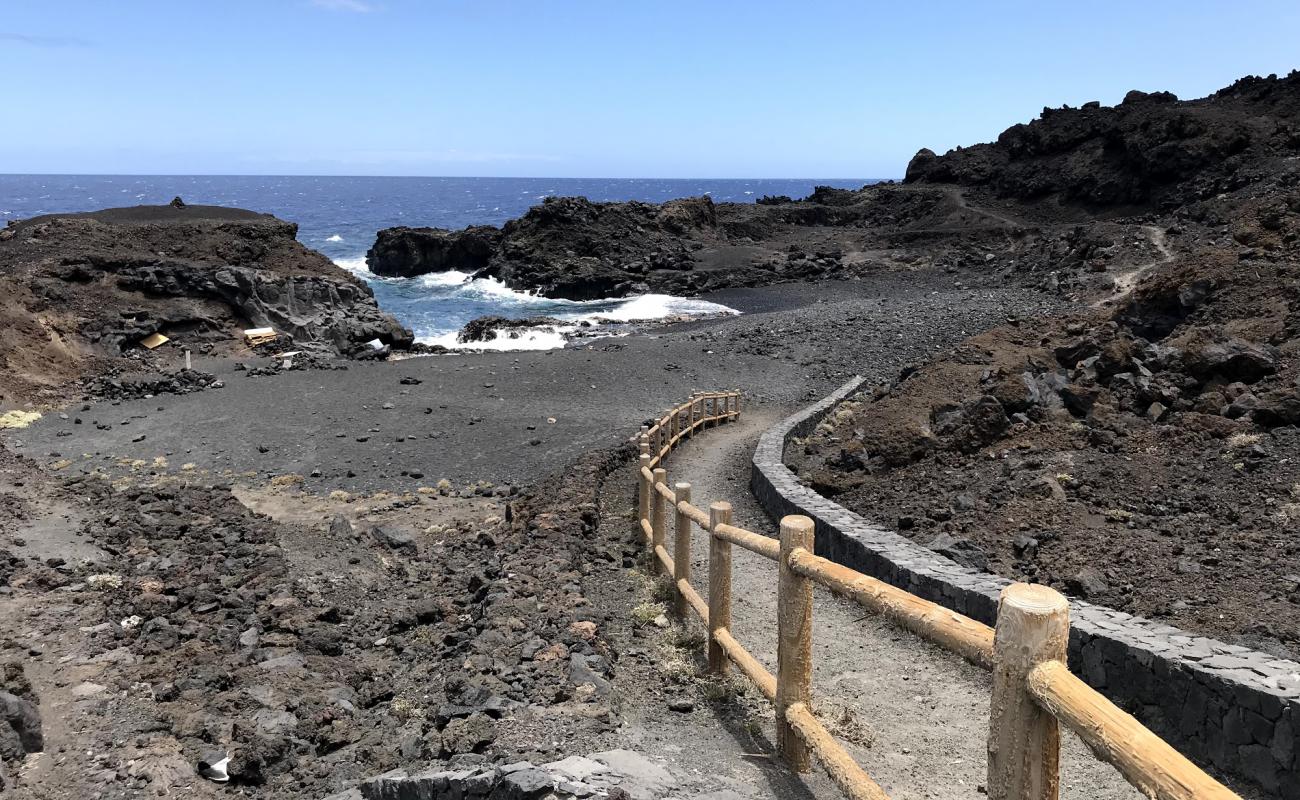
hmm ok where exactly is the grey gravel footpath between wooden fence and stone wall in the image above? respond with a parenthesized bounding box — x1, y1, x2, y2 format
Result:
(644, 410, 1140, 800)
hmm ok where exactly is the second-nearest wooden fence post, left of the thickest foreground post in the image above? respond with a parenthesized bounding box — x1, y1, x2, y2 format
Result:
(776, 514, 813, 773)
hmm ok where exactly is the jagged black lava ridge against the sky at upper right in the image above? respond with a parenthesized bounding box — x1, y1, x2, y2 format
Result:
(906, 73, 1300, 211)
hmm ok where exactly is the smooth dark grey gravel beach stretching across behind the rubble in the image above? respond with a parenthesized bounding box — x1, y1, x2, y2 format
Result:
(8, 273, 1062, 490)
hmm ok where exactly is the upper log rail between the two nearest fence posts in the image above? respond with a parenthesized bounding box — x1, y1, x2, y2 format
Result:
(790, 553, 993, 670)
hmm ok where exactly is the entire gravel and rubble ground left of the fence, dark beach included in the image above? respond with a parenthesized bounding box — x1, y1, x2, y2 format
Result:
(0, 273, 1060, 797)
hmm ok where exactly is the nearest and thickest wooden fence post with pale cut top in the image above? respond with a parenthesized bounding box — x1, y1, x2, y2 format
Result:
(988, 583, 1070, 800)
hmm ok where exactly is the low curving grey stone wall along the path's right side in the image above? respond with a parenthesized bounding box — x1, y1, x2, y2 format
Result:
(750, 377, 1300, 800)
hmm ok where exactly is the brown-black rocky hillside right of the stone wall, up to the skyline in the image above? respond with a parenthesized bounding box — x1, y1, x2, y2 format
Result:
(789, 74, 1300, 676)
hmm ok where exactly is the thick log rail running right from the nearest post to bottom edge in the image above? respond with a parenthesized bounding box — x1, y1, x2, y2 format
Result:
(1026, 661, 1240, 800)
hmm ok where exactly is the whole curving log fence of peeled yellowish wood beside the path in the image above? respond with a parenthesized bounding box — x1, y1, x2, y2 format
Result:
(638, 392, 1239, 800)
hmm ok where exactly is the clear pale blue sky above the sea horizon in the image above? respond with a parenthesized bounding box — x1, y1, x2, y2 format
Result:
(0, 0, 1300, 178)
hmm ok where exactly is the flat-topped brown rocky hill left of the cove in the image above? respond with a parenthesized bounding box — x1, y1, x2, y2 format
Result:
(0, 203, 412, 405)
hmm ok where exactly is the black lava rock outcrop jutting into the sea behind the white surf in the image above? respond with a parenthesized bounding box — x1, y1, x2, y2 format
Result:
(368, 183, 977, 300)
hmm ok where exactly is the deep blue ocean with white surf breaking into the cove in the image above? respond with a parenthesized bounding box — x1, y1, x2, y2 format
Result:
(0, 176, 874, 349)
